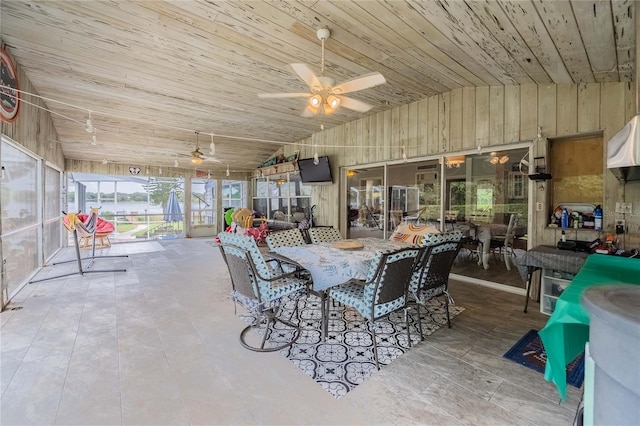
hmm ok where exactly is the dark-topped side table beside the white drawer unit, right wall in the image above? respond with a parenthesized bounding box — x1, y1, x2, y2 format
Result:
(516, 245, 589, 313)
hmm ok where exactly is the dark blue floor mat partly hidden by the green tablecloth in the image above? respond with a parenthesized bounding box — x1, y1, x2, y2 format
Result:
(503, 330, 584, 388)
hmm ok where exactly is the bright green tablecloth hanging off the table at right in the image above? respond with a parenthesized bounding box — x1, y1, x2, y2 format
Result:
(539, 254, 640, 400)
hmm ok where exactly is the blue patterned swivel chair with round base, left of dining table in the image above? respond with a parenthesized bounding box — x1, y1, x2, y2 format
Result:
(218, 232, 309, 352)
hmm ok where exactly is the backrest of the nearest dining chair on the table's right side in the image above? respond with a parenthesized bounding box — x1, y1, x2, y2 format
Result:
(364, 247, 424, 320)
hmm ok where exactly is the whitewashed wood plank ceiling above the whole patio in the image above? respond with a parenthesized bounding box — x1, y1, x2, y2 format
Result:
(0, 0, 635, 171)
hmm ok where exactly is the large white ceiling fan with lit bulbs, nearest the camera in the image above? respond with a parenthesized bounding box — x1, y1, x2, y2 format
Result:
(258, 28, 387, 117)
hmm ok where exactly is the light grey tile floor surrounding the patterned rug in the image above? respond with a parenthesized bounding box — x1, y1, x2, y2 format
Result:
(0, 239, 581, 425)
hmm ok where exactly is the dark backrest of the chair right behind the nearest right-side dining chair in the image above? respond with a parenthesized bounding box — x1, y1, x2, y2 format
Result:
(411, 240, 462, 296)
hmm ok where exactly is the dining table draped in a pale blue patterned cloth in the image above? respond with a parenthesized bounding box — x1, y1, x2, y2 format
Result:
(267, 238, 409, 339)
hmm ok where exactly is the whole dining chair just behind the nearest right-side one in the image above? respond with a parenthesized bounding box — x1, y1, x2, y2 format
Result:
(409, 231, 462, 340)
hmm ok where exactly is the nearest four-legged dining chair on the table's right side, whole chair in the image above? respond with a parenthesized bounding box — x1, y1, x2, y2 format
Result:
(329, 247, 424, 370)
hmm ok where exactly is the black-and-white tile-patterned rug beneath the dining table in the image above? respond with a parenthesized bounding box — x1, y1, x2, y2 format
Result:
(250, 296, 464, 398)
